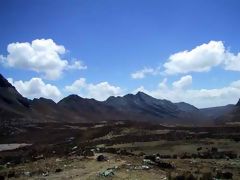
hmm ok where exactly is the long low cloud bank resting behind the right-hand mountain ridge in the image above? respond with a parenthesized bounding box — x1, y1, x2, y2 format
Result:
(134, 76, 240, 108)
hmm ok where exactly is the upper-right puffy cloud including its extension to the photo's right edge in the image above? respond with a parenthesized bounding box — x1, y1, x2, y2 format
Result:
(163, 41, 240, 74)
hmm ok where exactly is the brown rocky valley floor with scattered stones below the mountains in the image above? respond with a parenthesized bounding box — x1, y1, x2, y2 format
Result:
(0, 122, 240, 180)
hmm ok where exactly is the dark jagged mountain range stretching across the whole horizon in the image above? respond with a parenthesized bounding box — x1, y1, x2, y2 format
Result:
(0, 74, 240, 125)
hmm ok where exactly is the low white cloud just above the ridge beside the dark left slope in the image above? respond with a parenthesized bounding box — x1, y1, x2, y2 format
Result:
(8, 78, 62, 101)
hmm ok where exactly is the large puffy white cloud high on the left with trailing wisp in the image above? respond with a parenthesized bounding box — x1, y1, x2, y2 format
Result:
(0, 39, 87, 80)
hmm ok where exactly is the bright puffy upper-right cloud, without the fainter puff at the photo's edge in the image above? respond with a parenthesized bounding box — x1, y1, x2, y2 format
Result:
(164, 41, 225, 74)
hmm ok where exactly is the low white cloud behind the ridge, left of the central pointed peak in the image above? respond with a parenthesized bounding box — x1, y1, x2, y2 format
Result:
(65, 78, 123, 100)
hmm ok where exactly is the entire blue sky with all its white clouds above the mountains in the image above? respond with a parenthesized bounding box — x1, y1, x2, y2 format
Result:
(0, 0, 240, 108)
